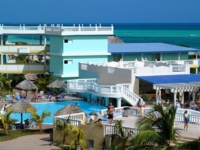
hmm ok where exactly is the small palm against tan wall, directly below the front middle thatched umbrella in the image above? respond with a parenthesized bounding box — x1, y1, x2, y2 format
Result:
(56, 116, 75, 144)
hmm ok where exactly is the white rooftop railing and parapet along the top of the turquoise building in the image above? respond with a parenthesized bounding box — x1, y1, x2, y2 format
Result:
(0, 24, 114, 35)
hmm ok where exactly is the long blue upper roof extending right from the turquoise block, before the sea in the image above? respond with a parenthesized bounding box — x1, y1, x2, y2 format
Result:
(108, 43, 200, 54)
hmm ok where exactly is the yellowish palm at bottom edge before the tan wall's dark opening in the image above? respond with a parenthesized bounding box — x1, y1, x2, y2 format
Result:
(71, 126, 86, 150)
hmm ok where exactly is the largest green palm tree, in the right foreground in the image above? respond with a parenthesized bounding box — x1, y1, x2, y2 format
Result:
(129, 104, 179, 149)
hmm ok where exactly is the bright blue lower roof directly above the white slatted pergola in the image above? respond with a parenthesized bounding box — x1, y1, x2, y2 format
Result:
(137, 74, 200, 84)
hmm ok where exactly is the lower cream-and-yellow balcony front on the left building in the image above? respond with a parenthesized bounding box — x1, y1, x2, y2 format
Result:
(0, 64, 49, 74)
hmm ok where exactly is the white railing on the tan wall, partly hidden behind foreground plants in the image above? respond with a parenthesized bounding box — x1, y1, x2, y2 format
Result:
(104, 124, 138, 138)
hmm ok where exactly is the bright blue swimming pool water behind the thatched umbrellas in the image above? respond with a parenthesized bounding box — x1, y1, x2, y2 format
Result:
(11, 101, 106, 124)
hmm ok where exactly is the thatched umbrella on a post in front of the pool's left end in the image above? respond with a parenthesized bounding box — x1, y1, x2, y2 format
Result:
(8, 100, 36, 124)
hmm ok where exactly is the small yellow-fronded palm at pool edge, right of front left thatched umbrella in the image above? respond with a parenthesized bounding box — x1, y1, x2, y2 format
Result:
(28, 108, 51, 133)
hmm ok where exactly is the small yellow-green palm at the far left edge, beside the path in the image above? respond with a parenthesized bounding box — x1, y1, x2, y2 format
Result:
(1, 111, 17, 135)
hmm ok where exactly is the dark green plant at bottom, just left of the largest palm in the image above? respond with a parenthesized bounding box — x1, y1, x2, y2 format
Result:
(110, 120, 133, 150)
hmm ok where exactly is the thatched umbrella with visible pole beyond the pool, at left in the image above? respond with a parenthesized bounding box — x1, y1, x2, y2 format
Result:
(16, 80, 38, 96)
